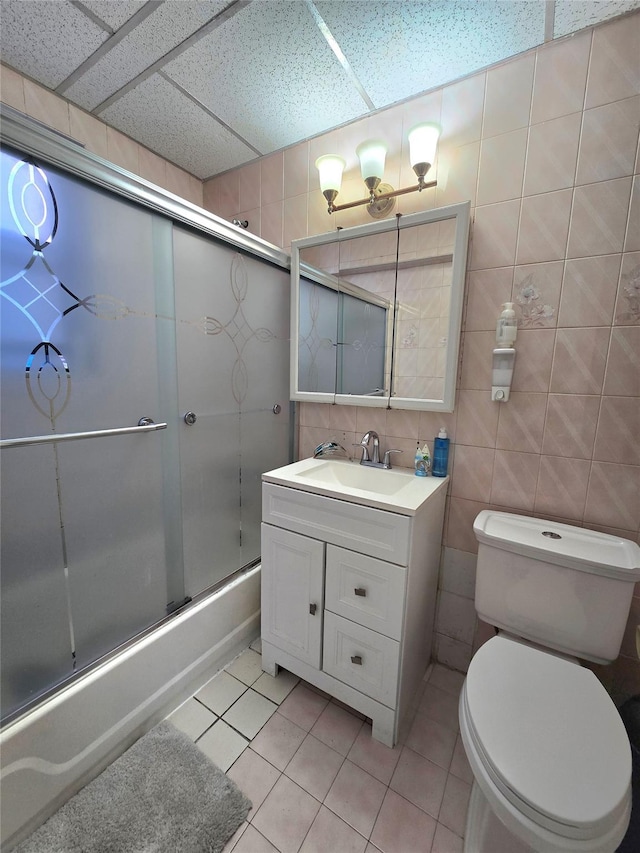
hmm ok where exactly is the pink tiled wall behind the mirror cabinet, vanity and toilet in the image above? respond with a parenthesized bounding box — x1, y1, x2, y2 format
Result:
(204, 13, 640, 698)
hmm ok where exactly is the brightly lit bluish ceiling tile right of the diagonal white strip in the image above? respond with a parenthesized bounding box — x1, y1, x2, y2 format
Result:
(315, 0, 545, 107)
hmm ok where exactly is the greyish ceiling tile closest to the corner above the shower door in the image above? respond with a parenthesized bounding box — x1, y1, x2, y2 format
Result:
(102, 74, 256, 179)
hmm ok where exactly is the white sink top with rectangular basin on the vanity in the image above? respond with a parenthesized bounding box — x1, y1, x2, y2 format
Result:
(262, 459, 447, 515)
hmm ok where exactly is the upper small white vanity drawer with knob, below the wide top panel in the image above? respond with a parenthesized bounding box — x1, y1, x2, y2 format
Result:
(325, 545, 407, 640)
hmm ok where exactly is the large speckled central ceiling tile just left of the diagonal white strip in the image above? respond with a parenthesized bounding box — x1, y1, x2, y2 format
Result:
(164, 0, 367, 154)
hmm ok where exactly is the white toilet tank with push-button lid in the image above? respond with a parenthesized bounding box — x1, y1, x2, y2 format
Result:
(473, 510, 640, 663)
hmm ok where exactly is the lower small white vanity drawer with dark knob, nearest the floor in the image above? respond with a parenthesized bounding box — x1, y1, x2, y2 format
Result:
(322, 610, 400, 708)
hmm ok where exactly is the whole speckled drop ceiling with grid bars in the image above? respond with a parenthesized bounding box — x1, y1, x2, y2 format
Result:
(0, 0, 640, 179)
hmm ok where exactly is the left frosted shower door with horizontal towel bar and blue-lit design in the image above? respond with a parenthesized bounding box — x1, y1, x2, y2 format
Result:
(0, 151, 181, 716)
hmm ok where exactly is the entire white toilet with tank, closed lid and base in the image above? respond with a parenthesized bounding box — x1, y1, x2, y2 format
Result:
(459, 510, 640, 853)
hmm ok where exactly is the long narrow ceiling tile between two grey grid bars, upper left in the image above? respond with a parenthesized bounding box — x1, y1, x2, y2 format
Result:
(64, 0, 228, 111)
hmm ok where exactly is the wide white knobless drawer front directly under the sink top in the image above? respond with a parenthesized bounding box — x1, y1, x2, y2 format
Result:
(262, 483, 411, 566)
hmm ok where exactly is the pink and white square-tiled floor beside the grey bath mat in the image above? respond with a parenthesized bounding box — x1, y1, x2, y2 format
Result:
(169, 640, 472, 853)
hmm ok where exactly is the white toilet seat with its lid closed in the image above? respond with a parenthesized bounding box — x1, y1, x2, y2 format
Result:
(460, 636, 631, 847)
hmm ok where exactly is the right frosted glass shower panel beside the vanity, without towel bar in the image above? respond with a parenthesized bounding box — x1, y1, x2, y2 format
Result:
(174, 228, 289, 596)
